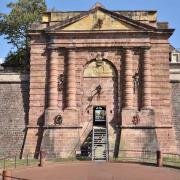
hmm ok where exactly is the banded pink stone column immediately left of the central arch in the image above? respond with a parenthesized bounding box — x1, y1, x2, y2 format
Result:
(66, 49, 76, 109)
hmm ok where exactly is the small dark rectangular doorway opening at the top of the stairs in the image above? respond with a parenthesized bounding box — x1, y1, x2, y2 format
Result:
(93, 106, 106, 125)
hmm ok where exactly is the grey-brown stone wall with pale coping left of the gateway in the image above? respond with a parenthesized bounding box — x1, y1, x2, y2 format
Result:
(0, 73, 29, 157)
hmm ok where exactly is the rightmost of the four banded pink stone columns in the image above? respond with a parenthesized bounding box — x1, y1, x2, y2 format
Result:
(142, 48, 152, 109)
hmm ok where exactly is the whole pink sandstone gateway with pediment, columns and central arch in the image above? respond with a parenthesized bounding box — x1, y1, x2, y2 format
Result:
(0, 3, 177, 160)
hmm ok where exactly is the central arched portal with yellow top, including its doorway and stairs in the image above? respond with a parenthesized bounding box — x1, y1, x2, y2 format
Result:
(81, 59, 118, 159)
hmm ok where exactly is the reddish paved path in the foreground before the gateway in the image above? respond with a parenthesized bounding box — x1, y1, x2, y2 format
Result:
(12, 162, 180, 180)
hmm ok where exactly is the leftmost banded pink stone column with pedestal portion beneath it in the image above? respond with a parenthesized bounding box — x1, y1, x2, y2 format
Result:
(45, 48, 59, 125)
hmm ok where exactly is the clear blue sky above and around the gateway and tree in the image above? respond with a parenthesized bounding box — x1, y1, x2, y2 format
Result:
(0, 0, 180, 61)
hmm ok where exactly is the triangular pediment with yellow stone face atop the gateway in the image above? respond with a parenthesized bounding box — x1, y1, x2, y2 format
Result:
(47, 7, 157, 31)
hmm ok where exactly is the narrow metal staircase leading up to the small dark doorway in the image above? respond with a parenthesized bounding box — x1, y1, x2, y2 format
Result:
(92, 126, 109, 161)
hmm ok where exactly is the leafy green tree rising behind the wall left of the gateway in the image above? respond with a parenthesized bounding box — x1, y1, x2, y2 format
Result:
(0, 0, 46, 70)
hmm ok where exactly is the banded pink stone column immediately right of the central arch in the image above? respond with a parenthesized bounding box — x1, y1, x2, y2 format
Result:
(124, 49, 133, 109)
